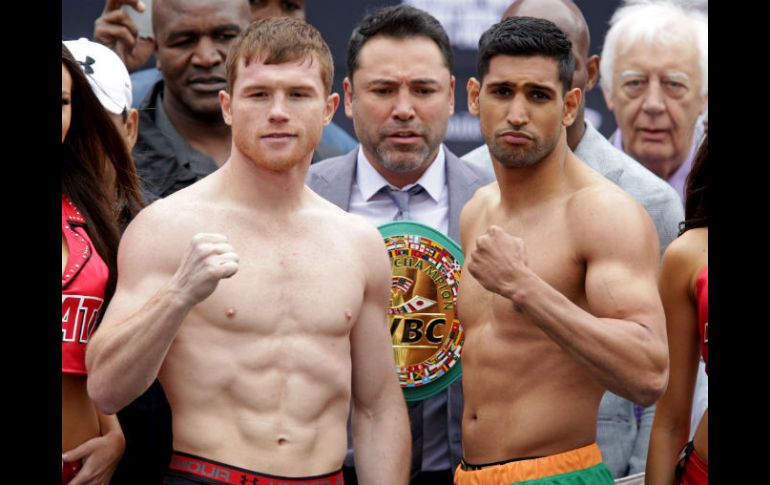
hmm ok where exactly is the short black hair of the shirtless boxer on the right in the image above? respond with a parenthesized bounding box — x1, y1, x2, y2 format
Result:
(476, 17, 575, 93)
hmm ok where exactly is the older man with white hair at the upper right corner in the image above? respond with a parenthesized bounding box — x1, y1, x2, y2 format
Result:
(600, 1, 708, 199)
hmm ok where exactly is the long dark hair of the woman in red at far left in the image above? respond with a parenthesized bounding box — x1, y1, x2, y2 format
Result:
(61, 43, 144, 304)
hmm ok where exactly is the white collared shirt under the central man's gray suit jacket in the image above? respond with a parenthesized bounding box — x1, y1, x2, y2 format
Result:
(349, 145, 449, 234)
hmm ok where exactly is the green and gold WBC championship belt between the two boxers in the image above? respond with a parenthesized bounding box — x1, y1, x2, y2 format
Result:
(379, 221, 465, 401)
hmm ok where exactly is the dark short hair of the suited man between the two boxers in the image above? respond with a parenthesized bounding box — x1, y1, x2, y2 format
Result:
(347, 5, 454, 77)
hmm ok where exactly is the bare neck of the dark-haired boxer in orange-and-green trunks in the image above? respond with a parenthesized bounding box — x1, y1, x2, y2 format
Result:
(493, 136, 573, 210)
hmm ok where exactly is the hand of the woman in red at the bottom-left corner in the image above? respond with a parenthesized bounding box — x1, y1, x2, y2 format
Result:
(62, 428, 126, 485)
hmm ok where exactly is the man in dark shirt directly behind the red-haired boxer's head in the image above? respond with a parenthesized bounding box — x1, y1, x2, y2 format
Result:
(96, 0, 250, 197)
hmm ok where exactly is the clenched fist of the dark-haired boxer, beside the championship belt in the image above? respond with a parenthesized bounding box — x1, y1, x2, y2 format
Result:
(468, 226, 532, 299)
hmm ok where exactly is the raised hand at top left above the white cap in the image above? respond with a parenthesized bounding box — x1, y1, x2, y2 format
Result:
(94, 0, 155, 72)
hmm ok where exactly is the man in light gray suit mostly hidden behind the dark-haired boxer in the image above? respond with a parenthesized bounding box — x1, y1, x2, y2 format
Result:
(456, 0, 684, 478)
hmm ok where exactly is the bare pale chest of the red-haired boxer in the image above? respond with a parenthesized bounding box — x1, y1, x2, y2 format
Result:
(189, 232, 364, 335)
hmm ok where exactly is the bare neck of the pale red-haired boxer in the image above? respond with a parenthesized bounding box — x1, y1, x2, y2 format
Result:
(215, 147, 313, 212)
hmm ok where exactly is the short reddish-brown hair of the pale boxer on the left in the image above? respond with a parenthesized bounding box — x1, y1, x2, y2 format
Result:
(225, 17, 334, 96)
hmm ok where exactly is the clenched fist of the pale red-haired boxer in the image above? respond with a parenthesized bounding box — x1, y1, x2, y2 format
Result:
(171, 233, 238, 305)
